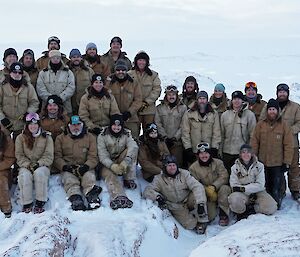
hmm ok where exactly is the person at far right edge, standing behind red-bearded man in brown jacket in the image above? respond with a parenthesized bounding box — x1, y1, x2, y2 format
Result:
(260, 83, 300, 201)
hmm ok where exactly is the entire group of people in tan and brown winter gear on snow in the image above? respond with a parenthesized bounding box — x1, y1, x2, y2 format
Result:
(0, 36, 300, 234)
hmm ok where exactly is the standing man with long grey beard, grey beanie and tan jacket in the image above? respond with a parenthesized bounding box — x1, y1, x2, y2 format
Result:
(181, 91, 221, 164)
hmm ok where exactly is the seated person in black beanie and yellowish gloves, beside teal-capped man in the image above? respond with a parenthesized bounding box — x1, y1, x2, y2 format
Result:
(97, 114, 138, 210)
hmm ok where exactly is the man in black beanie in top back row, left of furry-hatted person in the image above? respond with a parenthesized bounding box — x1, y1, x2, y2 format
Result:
(100, 36, 132, 74)
